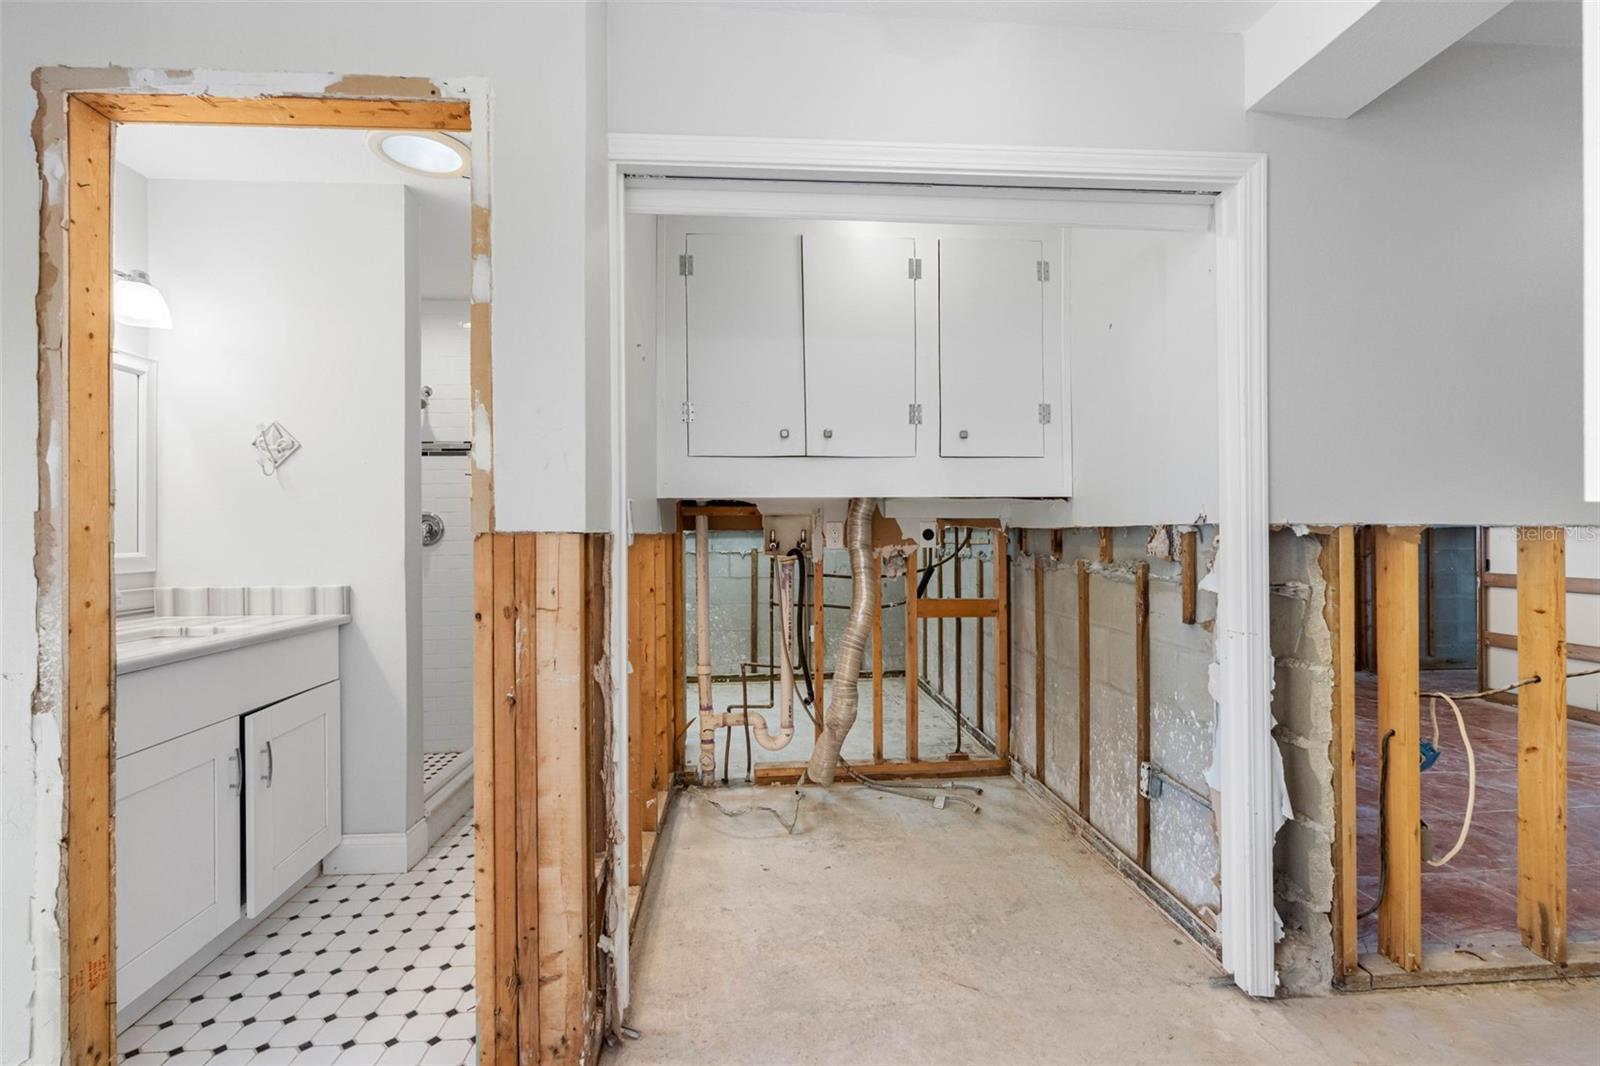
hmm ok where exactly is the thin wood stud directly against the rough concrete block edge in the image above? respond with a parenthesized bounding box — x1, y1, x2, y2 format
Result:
(1322, 525, 1358, 980)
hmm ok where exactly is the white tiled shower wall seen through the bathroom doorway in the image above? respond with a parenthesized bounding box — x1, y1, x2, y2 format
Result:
(421, 299, 472, 751)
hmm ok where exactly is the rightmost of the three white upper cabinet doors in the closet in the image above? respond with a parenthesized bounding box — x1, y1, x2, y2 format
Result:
(939, 238, 1045, 458)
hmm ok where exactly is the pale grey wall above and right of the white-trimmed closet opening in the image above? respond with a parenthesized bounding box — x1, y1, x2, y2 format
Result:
(610, 3, 1600, 523)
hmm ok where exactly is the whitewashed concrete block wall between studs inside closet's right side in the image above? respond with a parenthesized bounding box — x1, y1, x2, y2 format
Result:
(1011, 527, 1218, 911)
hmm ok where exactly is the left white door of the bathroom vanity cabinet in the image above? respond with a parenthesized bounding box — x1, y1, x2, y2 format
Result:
(117, 719, 242, 1004)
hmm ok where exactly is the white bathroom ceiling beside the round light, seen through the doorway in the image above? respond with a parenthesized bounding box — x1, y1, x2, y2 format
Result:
(115, 123, 472, 299)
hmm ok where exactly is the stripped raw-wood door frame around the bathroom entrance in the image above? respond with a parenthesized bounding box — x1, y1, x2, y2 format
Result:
(34, 76, 493, 1063)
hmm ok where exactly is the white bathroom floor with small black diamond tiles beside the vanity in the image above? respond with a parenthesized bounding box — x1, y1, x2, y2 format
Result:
(118, 815, 477, 1066)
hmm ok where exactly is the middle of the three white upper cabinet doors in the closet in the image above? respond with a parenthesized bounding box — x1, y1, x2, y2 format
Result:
(805, 234, 917, 456)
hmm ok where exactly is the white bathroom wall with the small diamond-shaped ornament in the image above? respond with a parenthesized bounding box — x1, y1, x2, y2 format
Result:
(149, 181, 422, 834)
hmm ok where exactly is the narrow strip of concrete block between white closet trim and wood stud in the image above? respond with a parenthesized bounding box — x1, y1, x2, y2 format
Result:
(1269, 528, 1333, 996)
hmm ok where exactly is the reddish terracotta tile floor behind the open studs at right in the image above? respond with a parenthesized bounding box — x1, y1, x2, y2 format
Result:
(1355, 671, 1600, 952)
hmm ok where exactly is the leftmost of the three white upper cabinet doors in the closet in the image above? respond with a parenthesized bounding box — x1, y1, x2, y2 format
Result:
(683, 234, 805, 456)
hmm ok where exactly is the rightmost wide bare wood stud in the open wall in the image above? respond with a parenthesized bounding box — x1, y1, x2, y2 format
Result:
(1517, 527, 1566, 965)
